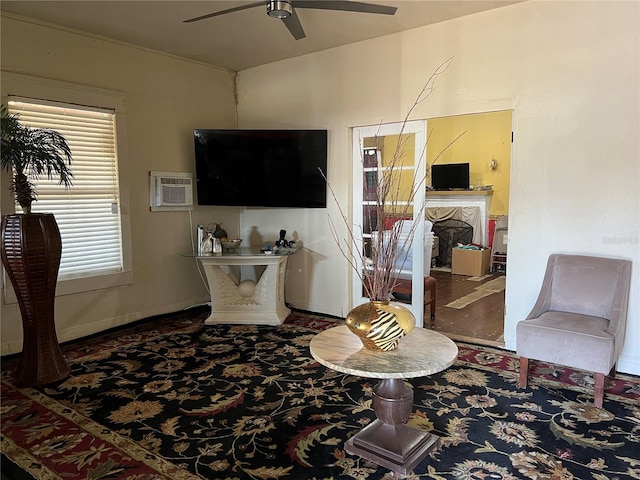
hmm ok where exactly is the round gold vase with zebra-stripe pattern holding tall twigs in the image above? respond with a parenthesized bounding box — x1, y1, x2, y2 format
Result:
(346, 301, 416, 352)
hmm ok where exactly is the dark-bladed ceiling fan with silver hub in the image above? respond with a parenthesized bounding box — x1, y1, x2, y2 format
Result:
(183, 0, 397, 40)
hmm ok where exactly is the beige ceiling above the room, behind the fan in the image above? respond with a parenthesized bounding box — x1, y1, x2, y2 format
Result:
(0, 0, 522, 71)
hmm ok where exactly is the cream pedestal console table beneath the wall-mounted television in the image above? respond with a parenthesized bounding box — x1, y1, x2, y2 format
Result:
(185, 247, 299, 325)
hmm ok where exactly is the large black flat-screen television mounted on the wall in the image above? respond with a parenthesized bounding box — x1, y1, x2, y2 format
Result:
(193, 129, 327, 208)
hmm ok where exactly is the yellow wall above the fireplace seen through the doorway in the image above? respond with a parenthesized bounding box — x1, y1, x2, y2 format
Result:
(427, 110, 511, 216)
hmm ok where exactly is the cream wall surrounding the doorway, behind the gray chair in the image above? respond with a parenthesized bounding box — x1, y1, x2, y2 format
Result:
(238, 1, 640, 374)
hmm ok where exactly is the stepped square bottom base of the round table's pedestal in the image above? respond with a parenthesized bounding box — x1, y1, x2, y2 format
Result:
(345, 420, 440, 477)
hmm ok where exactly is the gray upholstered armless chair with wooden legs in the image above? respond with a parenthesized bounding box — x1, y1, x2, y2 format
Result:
(516, 254, 631, 408)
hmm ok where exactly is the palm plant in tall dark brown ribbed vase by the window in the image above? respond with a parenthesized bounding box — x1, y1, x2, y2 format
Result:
(0, 105, 73, 386)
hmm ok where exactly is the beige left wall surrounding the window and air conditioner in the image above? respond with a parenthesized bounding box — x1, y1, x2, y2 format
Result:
(0, 16, 237, 354)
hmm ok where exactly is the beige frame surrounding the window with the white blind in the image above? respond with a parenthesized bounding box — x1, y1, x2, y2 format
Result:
(0, 71, 133, 304)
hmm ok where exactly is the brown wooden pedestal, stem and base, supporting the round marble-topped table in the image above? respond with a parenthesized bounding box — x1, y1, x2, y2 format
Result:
(345, 378, 440, 477)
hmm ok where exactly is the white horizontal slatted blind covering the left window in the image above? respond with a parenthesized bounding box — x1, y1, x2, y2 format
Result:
(8, 97, 123, 279)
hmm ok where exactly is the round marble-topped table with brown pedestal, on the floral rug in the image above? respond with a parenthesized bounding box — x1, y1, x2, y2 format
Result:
(309, 325, 458, 476)
